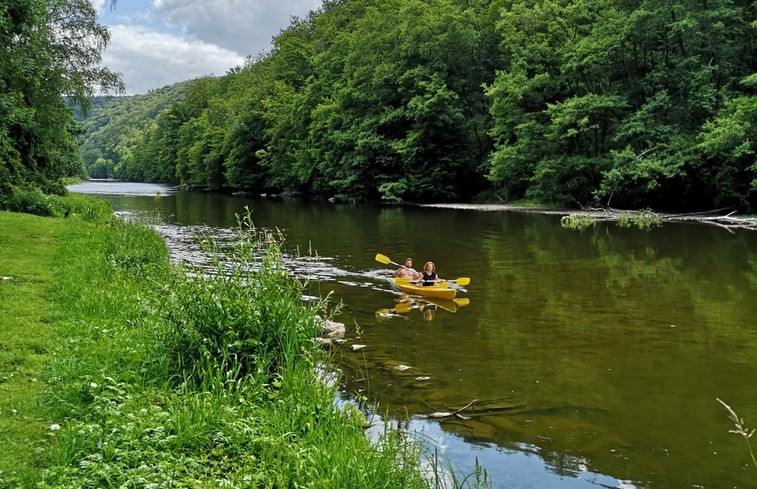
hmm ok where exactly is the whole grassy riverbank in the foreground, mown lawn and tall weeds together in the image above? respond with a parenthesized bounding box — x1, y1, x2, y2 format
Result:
(0, 207, 448, 488)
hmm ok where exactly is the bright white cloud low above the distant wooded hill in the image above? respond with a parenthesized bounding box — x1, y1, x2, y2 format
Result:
(103, 25, 244, 94)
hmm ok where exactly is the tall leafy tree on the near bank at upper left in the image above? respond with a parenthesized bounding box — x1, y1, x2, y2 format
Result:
(0, 0, 122, 194)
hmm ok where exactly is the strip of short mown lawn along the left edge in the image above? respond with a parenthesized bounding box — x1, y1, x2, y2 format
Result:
(0, 211, 66, 487)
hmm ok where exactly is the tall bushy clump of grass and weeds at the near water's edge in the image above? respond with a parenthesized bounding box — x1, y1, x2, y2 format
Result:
(165, 215, 318, 385)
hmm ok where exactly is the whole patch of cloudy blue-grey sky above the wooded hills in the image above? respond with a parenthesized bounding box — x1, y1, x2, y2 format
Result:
(90, 0, 322, 95)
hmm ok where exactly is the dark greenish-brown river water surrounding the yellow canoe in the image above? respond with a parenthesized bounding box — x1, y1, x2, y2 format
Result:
(71, 180, 757, 489)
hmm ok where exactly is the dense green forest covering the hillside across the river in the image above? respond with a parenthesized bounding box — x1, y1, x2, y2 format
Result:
(0, 0, 757, 212)
